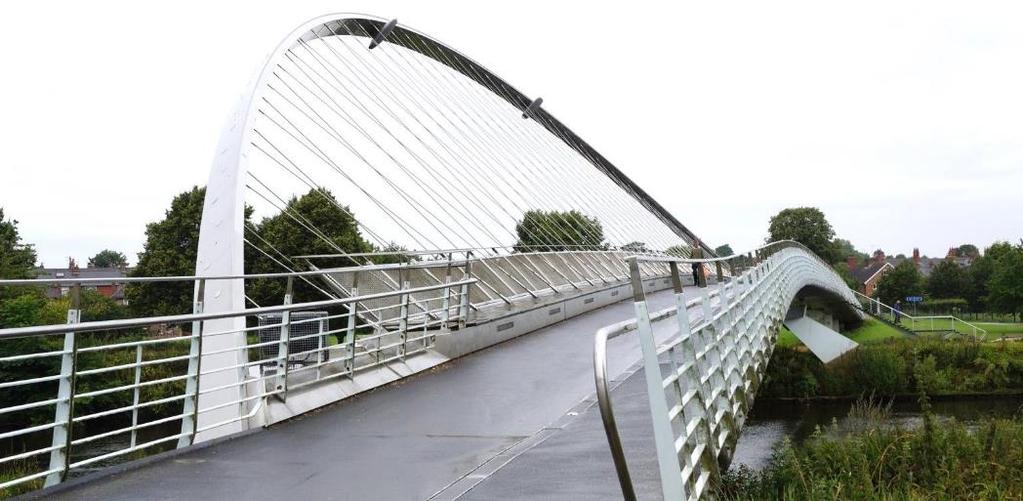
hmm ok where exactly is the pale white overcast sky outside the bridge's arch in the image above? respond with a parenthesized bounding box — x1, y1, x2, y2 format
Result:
(0, 0, 1023, 266)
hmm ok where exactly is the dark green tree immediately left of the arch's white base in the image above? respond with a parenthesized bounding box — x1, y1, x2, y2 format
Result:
(125, 186, 206, 316)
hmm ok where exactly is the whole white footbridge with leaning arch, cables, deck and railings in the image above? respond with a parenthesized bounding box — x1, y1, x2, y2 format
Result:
(0, 14, 864, 500)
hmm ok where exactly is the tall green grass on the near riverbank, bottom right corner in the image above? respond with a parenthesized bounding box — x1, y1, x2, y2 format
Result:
(718, 398, 1023, 500)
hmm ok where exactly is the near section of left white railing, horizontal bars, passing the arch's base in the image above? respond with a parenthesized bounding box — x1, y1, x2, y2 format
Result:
(0, 270, 477, 492)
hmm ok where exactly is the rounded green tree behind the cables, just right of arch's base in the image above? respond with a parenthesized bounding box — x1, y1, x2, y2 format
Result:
(246, 188, 374, 306)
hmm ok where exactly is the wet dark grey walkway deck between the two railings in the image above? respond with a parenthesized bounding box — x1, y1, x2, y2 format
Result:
(43, 291, 699, 500)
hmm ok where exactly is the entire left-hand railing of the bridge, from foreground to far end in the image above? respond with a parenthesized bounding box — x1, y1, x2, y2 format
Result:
(0, 249, 679, 492)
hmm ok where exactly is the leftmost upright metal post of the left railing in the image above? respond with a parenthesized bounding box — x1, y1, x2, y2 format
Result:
(43, 284, 82, 487)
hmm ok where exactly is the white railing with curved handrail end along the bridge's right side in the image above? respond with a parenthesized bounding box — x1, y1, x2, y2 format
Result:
(593, 241, 856, 499)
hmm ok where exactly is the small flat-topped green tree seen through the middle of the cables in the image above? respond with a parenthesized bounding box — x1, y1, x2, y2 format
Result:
(515, 210, 607, 253)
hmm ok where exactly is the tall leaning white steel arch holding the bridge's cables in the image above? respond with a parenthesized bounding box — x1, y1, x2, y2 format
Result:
(193, 13, 713, 440)
